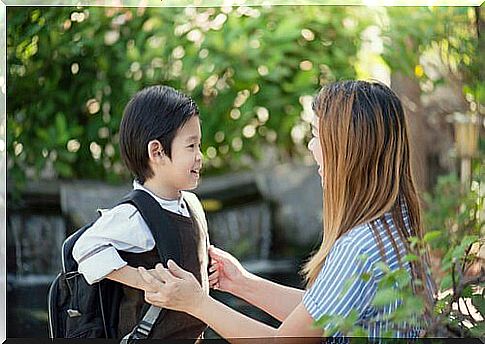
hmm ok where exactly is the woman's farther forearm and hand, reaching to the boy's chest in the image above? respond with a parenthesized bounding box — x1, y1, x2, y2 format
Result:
(209, 246, 303, 321)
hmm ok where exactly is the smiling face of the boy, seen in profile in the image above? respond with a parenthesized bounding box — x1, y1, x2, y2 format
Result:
(157, 116, 202, 192)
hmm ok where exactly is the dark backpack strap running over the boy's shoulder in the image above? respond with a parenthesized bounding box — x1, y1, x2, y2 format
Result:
(118, 190, 181, 264)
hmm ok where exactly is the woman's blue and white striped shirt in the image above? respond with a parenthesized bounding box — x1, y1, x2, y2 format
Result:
(303, 213, 428, 338)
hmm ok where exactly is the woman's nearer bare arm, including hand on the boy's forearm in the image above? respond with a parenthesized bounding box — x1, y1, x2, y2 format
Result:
(139, 261, 322, 343)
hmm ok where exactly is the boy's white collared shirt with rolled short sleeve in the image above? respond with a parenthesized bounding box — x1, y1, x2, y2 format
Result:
(72, 181, 190, 284)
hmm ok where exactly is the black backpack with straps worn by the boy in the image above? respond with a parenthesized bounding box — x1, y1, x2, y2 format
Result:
(48, 190, 180, 339)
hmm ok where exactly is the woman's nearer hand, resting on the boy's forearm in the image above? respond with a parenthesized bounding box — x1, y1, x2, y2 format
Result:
(138, 260, 207, 313)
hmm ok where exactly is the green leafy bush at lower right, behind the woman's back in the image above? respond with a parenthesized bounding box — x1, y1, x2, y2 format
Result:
(424, 160, 485, 339)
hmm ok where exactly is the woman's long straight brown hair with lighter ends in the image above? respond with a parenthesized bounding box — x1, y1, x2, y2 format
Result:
(302, 81, 433, 320)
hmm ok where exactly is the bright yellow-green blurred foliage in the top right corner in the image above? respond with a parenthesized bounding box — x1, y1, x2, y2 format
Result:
(380, 5, 485, 106)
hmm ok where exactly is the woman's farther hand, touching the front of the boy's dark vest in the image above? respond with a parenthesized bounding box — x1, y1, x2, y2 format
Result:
(209, 246, 251, 294)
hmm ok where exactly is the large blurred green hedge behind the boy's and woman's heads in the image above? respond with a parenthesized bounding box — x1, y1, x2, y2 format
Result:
(7, 6, 368, 185)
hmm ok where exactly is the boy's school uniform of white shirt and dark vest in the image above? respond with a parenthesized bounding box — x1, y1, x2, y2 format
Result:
(72, 181, 209, 339)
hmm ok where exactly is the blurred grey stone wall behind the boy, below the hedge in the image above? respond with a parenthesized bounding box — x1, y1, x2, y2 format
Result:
(7, 164, 322, 275)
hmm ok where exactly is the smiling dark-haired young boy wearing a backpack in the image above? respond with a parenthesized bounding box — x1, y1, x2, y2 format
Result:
(73, 86, 209, 339)
